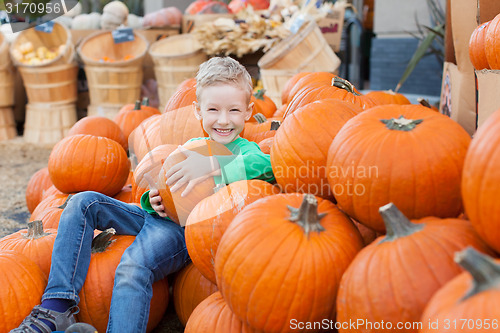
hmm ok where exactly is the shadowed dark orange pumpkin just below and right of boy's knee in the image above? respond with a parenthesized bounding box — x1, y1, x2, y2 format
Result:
(173, 263, 217, 326)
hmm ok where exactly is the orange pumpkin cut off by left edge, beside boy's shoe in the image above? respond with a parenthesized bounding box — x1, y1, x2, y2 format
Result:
(0, 250, 47, 332)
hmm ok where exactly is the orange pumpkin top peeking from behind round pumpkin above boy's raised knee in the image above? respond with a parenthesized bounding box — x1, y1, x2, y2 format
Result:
(66, 116, 128, 150)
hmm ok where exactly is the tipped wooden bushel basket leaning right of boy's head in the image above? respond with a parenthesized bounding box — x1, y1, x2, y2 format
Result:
(258, 21, 340, 106)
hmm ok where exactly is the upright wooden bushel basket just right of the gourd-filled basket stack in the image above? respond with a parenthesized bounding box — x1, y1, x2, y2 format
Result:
(78, 31, 149, 118)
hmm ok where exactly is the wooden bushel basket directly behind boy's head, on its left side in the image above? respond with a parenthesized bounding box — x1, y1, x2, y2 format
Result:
(149, 34, 208, 110)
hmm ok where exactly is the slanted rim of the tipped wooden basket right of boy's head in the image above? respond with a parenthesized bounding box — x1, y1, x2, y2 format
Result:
(257, 20, 317, 69)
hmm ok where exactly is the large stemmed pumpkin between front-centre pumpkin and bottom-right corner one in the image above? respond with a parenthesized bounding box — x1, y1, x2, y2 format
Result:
(337, 204, 489, 333)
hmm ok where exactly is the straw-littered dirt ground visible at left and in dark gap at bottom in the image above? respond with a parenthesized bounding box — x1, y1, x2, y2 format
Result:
(0, 137, 184, 333)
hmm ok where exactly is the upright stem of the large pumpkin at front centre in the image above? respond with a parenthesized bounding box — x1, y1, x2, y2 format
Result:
(287, 194, 326, 236)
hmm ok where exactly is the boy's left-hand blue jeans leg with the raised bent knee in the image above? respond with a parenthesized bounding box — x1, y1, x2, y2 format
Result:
(42, 191, 149, 303)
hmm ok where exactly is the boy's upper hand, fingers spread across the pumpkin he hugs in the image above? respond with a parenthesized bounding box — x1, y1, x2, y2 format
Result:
(165, 146, 220, 197)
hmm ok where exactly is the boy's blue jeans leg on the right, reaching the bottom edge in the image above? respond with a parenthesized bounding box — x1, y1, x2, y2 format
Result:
(106, 215, 189, 333)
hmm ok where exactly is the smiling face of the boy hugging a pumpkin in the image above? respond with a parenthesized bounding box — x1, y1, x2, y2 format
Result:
(194, 83, 253, 144)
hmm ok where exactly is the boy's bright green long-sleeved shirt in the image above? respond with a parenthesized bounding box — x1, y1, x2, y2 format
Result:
(141, 137, 275, 214)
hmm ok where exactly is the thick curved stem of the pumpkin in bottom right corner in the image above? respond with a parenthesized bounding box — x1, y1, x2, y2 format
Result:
(455, 247, 500, 301)
